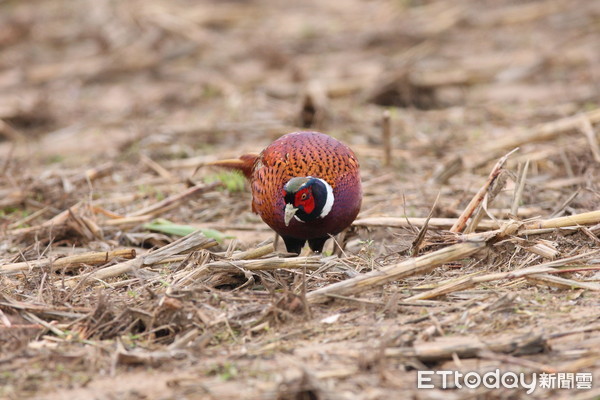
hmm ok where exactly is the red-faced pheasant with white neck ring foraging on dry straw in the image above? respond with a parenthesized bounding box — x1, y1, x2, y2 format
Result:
(209, 132, 362, 254)
